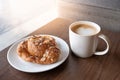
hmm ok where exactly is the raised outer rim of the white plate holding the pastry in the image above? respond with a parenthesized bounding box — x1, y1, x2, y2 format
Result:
(7, 34, 70, 73)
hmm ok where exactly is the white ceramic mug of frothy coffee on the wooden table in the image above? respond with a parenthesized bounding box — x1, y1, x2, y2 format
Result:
(69, 21, 110, 58)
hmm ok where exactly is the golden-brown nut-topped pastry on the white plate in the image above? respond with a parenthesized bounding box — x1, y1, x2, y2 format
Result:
(17, 35, 60, 64)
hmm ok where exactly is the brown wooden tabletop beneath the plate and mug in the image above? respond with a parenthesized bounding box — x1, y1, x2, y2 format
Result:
(0, 18, 120, 80)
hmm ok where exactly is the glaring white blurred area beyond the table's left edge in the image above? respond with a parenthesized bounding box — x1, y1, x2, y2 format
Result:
(0, 0, 56, 34)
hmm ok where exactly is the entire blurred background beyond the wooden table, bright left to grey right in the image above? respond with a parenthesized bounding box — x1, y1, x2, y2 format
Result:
(0, 0, 120, 34)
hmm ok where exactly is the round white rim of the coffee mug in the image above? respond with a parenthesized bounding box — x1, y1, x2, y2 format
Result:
(69, 21, 101, 36)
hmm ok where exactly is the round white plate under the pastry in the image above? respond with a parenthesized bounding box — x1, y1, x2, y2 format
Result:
(7, 35, 69, 73)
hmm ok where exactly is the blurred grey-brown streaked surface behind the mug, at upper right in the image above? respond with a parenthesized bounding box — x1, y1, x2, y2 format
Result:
(58, 0, 120, 32)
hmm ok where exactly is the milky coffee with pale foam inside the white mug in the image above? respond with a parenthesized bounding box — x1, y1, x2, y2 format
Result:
(72, 24, 97, 35)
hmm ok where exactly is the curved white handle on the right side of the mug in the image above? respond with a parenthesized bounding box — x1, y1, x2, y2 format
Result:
(95, 34, 110, 55)
